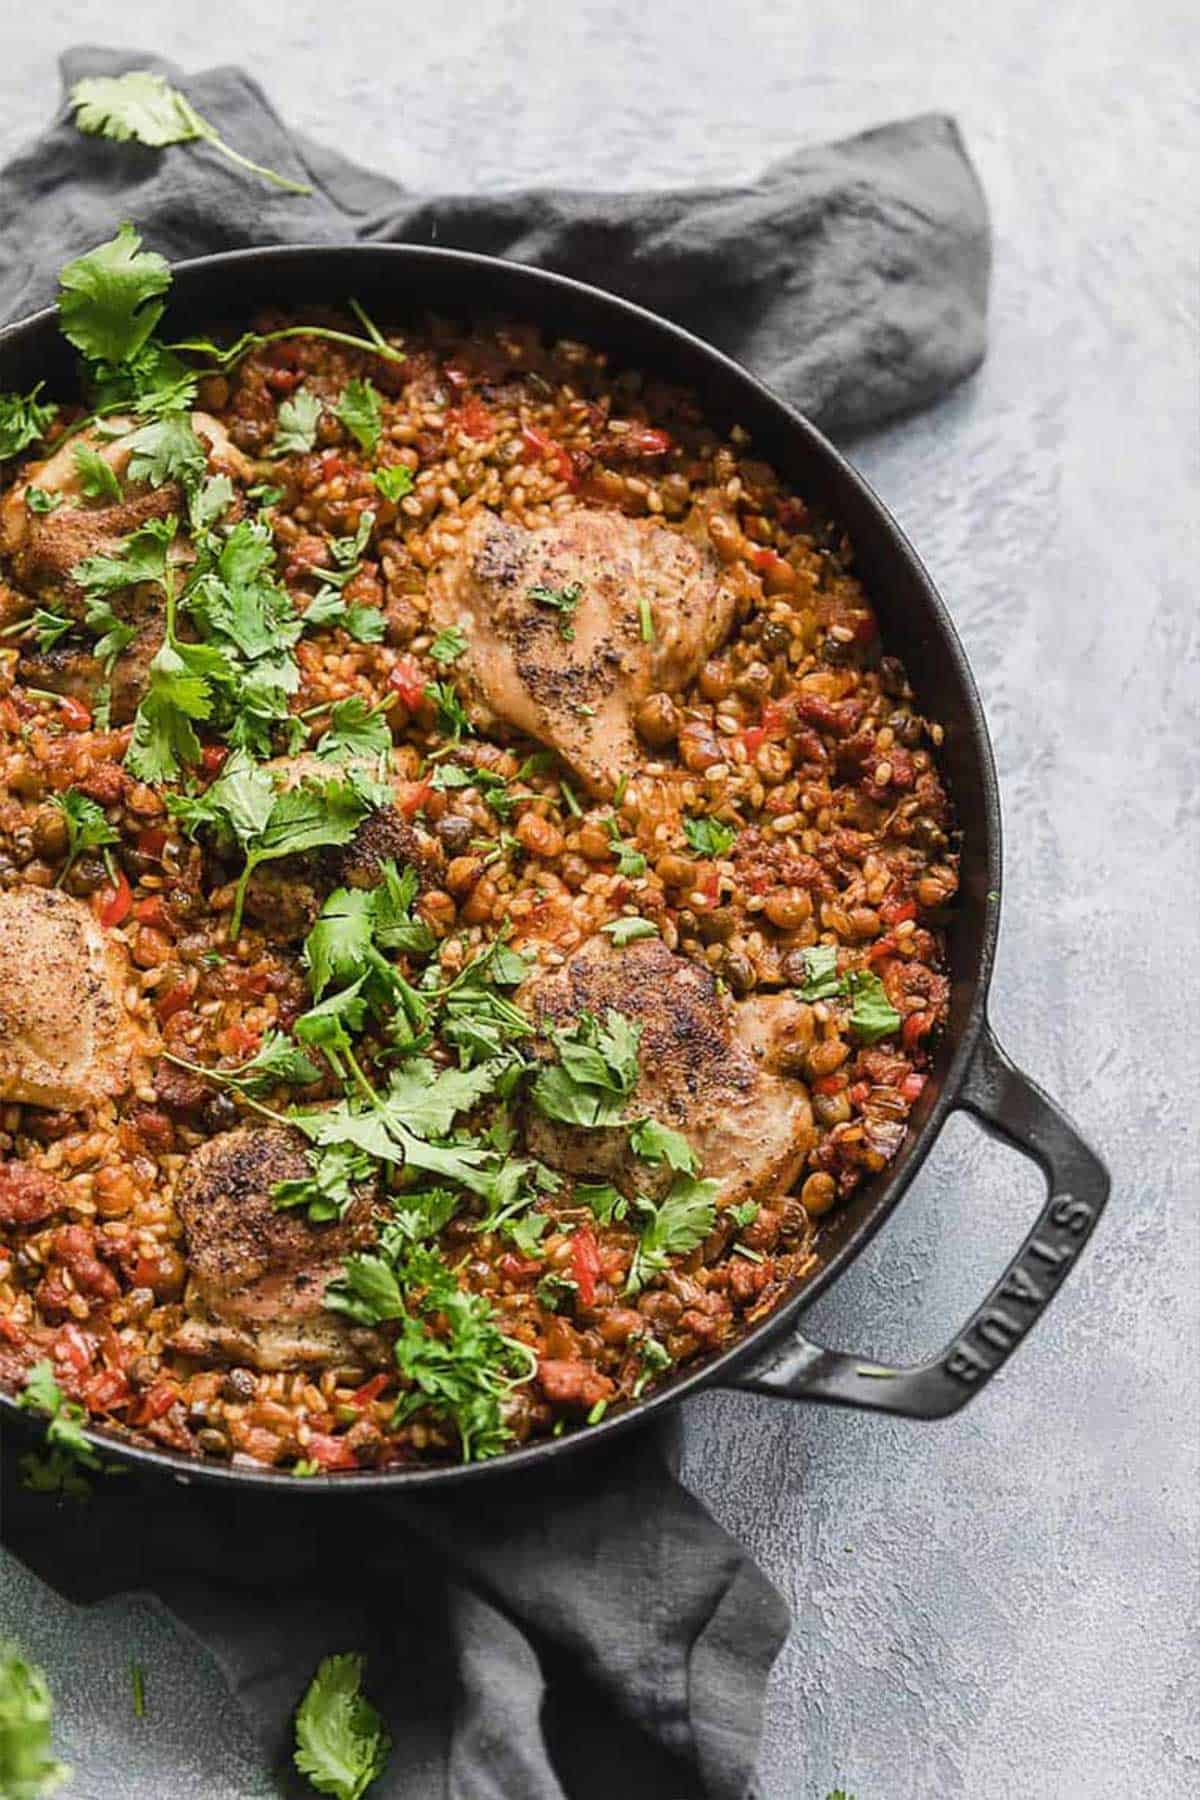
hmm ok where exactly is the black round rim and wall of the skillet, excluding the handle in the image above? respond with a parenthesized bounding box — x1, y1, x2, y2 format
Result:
(0, 245, 1000, 1496)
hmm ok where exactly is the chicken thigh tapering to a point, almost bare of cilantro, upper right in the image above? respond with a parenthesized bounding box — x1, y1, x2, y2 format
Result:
(430, 511, 734, 794)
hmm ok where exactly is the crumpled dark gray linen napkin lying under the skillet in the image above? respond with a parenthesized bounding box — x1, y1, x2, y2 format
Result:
(0, 49, 990, 1800)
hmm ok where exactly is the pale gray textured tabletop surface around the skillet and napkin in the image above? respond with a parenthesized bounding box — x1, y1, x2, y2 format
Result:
(0, 0, 1200, 1800)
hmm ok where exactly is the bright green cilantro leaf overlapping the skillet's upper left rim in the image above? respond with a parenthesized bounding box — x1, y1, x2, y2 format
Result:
(58, 223, 171, 364)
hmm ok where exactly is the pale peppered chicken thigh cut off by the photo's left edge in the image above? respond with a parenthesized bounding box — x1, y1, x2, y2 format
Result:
(0, 887, 148, 1112)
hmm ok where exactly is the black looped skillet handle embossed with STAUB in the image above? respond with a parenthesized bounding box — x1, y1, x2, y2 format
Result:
(727, 1024, 1110, 1418)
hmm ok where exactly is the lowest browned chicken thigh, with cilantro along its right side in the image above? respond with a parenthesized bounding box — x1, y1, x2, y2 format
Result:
(173, 1125, 383, 1370)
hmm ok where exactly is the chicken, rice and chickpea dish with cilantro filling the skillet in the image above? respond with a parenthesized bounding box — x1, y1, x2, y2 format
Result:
(0, 227, 957, 1474)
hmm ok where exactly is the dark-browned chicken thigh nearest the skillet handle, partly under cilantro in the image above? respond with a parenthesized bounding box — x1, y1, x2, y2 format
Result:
(522, 934, 813, 1206)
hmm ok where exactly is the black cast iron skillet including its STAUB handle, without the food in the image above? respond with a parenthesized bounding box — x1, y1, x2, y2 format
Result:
(0, 245, 1108, 1494)
